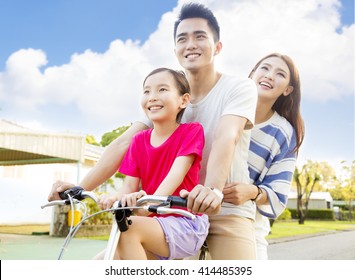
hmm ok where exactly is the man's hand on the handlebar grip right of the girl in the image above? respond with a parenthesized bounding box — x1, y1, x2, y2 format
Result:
(180, 185, 222, 215)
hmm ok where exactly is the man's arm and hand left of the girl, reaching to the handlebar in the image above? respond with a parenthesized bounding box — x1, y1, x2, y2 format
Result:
(48, 122, 148, 201)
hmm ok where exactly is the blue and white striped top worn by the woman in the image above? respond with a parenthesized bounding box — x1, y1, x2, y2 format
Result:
(248, 112, 296, 219)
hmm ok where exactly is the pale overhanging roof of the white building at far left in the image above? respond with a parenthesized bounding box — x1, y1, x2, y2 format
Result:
(0, 119, 103, 165)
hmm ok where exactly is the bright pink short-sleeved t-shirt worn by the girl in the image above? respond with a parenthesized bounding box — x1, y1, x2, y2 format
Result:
(119, 123, 204, 195)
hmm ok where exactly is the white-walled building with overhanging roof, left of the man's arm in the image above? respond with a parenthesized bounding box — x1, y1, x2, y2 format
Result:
(0, 120, 104, 224)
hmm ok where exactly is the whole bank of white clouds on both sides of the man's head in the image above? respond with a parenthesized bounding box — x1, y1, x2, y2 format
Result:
(0, 0, 354, 135)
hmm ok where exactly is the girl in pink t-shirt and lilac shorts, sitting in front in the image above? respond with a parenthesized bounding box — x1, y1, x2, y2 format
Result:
(100, 68, 209, 260)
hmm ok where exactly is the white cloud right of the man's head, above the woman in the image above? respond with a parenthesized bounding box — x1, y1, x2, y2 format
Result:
(207, 0, 355, 101)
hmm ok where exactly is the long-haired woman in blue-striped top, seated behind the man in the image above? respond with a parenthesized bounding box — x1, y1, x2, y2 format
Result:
(223, 53, 304, 259)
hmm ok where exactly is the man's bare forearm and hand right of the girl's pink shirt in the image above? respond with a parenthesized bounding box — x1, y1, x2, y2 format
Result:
(188, 115, 247, 215)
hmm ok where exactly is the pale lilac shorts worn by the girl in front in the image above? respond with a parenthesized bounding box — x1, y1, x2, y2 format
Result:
(154, 215, 210, 260)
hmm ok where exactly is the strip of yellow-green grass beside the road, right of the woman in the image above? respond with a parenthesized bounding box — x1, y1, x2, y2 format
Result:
(267, 220, 355, 239)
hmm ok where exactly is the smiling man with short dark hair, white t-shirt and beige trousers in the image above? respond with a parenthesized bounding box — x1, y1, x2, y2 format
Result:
(49, 3, 257, 259)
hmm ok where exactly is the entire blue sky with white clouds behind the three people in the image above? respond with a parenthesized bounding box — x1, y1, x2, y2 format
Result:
(0, 0, 355, 170)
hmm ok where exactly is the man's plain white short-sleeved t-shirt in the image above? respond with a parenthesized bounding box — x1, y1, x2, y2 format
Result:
(182, 75, 257, 219)
